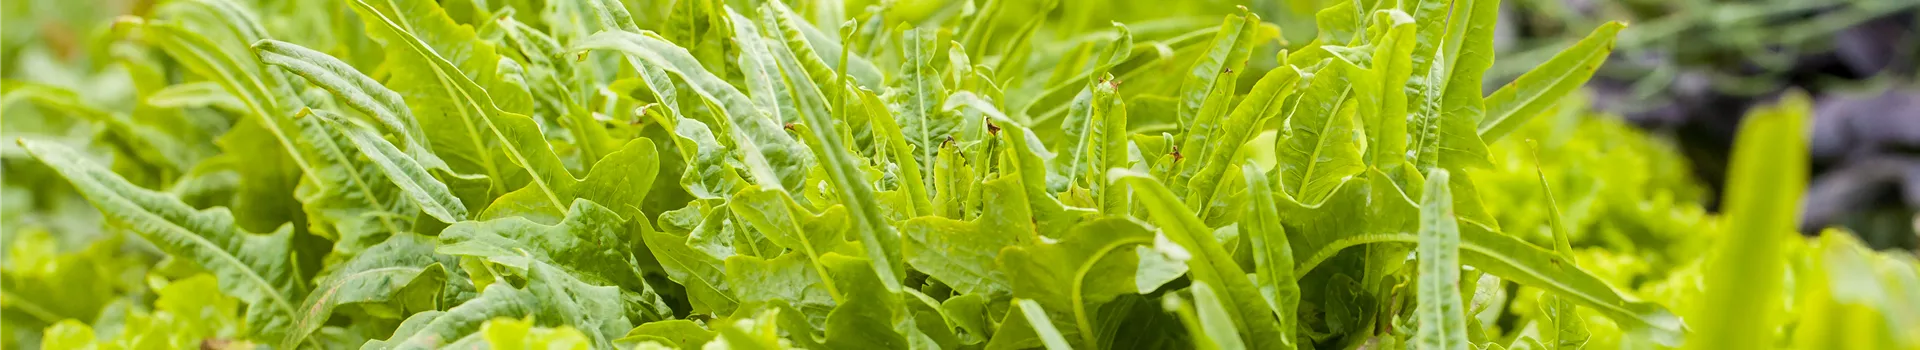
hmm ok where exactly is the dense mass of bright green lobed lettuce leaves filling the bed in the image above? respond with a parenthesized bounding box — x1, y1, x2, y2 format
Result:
(0, 0, 1920, 348)
